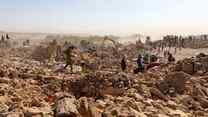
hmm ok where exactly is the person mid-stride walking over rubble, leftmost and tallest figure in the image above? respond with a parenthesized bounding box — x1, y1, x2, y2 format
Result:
(64, 45, 75, 73)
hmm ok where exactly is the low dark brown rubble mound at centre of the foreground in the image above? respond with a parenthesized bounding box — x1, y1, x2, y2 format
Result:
(69, 72, 132, 98)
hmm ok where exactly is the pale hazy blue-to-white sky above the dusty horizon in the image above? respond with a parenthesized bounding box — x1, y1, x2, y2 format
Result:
(0, 0, 208, 37)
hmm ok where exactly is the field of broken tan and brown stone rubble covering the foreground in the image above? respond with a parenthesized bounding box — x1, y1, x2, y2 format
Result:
(0, 42, 208, 117)
